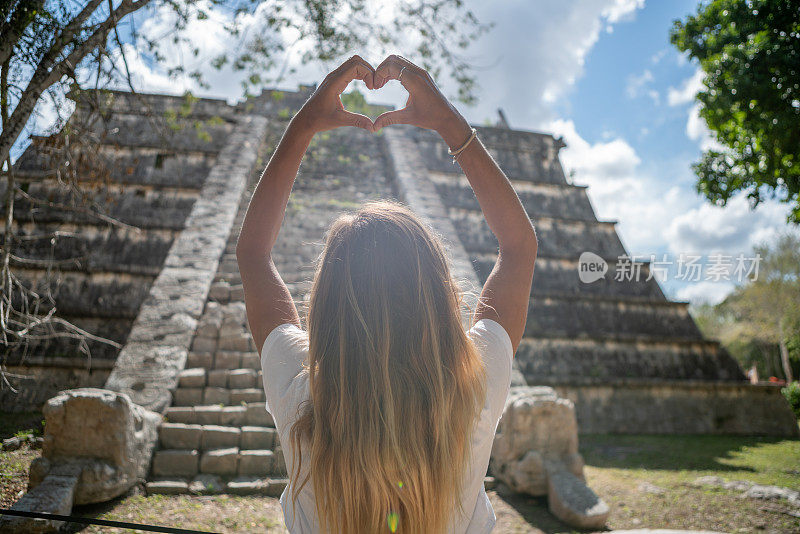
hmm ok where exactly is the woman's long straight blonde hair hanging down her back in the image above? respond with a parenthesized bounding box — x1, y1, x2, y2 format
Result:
(290, 201, 486, 534)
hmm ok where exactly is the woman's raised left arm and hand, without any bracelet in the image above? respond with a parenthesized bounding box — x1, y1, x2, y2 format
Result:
(236, 56, 374, 352)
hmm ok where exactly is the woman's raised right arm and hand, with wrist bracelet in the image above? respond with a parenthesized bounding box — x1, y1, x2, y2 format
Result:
(375, 56, 538, 351)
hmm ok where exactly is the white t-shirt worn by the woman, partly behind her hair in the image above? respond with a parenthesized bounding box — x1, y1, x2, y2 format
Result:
(261, 319, 513, 534)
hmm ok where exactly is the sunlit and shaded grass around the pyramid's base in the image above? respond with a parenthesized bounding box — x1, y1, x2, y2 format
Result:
(2, 430, 800, 533)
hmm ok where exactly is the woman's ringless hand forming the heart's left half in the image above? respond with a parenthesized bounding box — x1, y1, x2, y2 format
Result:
(292, 56, 375, 135)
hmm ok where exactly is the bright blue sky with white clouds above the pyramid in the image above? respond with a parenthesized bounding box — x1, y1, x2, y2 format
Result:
(18, 0, 797, 303)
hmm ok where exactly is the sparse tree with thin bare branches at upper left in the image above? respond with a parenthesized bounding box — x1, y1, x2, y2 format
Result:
(0, 0, 490, 385)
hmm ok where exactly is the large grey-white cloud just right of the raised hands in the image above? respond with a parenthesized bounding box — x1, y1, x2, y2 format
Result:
(450, 0, 644, 128)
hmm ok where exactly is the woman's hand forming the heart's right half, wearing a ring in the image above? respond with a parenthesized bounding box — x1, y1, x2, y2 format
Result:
(374, 55, 471, 148)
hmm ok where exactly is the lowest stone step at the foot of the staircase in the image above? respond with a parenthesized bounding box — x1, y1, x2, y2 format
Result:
(147, 474, 289, 497)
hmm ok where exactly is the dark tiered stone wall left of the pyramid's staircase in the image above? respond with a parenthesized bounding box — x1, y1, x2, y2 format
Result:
(0, 92, 241, 411)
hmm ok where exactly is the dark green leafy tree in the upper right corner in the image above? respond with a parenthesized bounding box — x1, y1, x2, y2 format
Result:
(670, 0, 800, 224)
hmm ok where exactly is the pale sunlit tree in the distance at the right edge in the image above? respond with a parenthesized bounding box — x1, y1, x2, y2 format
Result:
(718, 233, 800, 382)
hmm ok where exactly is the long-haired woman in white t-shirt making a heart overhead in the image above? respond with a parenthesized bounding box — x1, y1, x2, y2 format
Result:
(236, 56, 537, 534)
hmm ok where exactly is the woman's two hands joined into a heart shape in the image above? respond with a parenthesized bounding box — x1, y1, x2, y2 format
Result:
(293, 55, 466, 138)
